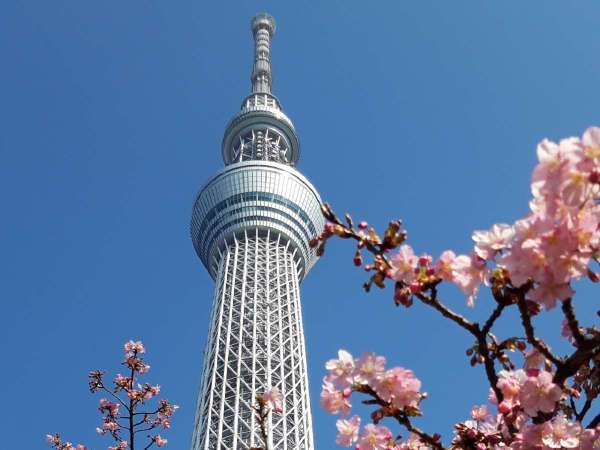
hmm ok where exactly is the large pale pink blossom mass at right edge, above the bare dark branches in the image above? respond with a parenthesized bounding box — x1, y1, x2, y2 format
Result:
(387, 127, 600, 309)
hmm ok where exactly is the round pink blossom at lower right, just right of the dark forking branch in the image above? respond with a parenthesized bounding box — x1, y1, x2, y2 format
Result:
(519, 370, 562, 417)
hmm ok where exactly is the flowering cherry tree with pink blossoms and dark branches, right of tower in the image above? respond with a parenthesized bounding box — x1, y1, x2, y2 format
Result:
(316, 127, 600, 450)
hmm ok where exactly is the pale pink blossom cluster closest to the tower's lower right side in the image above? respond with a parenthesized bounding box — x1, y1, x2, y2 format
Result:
(321, 350, 424, 450)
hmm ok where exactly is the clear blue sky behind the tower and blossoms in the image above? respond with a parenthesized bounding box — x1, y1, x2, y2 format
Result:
(0, 0, 600, 450)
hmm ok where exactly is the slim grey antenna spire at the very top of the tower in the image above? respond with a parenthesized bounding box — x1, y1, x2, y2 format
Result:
(251, 13, 275, 94)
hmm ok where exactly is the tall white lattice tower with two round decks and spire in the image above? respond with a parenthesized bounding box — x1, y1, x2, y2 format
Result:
(191, 14, 324, 450)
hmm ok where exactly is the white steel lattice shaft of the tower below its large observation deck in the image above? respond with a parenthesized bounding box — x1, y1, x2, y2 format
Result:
(192, 228, 313, 450)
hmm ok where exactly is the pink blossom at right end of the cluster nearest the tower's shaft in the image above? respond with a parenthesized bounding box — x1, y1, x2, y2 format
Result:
(373, 367, 421, 409)
